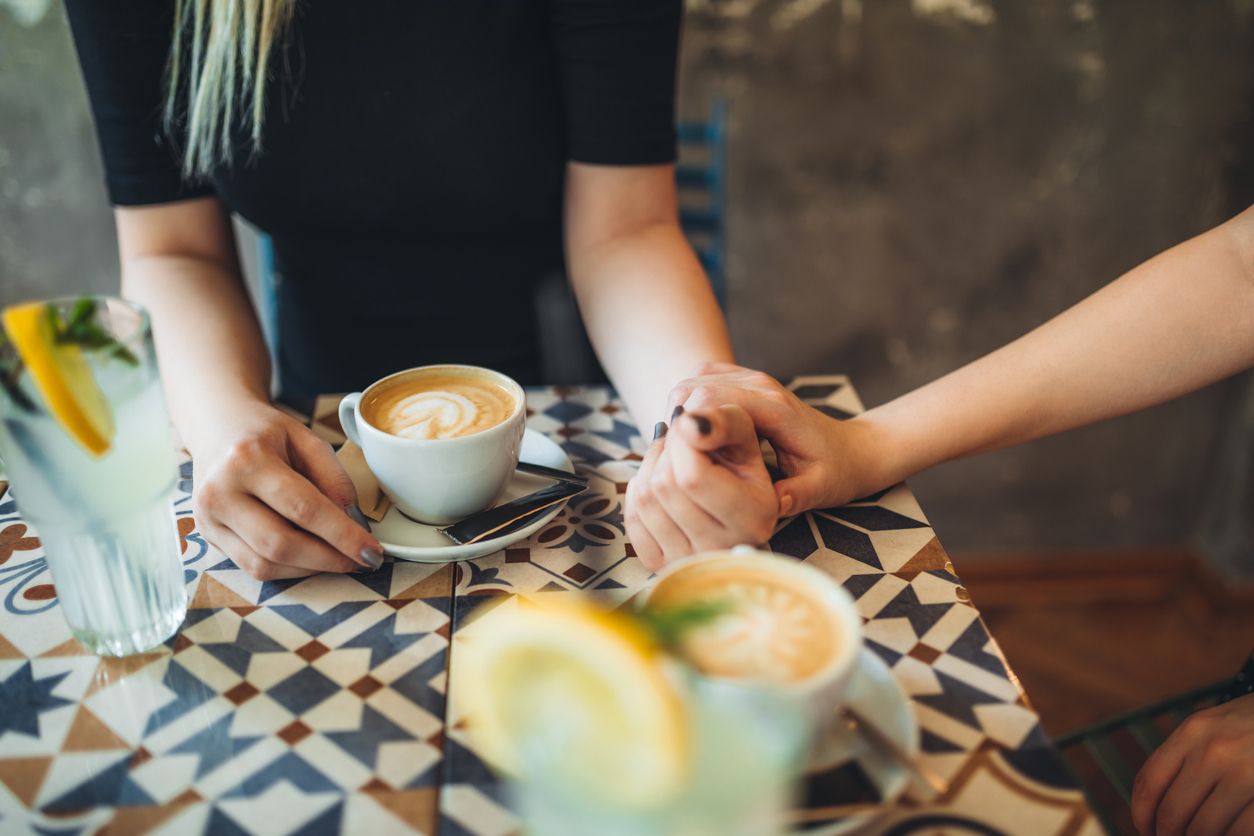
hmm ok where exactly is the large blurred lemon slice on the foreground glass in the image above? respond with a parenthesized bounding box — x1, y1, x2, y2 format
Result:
(453, 599, 690, 810)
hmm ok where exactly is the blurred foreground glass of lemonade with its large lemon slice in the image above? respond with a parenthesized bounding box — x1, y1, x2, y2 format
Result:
(450, 593, 809, 836)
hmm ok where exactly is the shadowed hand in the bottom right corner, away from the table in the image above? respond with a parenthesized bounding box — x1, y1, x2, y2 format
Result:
(1132, 694, 1254, 836)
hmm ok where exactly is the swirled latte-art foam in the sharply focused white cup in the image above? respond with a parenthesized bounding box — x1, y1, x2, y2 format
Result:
(361, 375, 517, 440)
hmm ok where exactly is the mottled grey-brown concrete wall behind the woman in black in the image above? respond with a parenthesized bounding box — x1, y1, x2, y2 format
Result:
(0, 0, 1254, 565)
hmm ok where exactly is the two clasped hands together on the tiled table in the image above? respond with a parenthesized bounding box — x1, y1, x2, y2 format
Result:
(626, 363, 888, 569)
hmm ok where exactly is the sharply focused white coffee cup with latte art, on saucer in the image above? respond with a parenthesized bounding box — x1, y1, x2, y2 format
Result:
(340, 365, 527, 525)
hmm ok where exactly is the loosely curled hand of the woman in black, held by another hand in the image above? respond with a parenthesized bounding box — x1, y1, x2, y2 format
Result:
(626, 405, 779, 570)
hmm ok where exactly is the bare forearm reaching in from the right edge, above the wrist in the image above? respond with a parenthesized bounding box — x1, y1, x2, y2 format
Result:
(858, 209, 1254, 480)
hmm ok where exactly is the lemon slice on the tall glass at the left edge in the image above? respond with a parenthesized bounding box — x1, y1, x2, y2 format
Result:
(3, 302, 114, 456)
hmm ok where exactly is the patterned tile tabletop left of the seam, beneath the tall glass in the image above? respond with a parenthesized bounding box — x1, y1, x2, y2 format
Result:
(0, 466, 453, 833)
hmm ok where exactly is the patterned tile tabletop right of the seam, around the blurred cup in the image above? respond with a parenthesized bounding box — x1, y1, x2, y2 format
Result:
(428, 376, 1100, 833)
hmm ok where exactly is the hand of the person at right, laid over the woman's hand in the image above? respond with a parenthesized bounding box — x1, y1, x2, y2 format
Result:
(671, 363, 907, 516)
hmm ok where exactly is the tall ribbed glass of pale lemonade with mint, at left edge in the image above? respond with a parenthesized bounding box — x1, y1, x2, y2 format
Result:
(0, 297, 187, 656)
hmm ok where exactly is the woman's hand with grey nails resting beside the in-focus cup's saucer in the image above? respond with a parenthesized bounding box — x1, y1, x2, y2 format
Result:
(192, 402, 382, 580)
